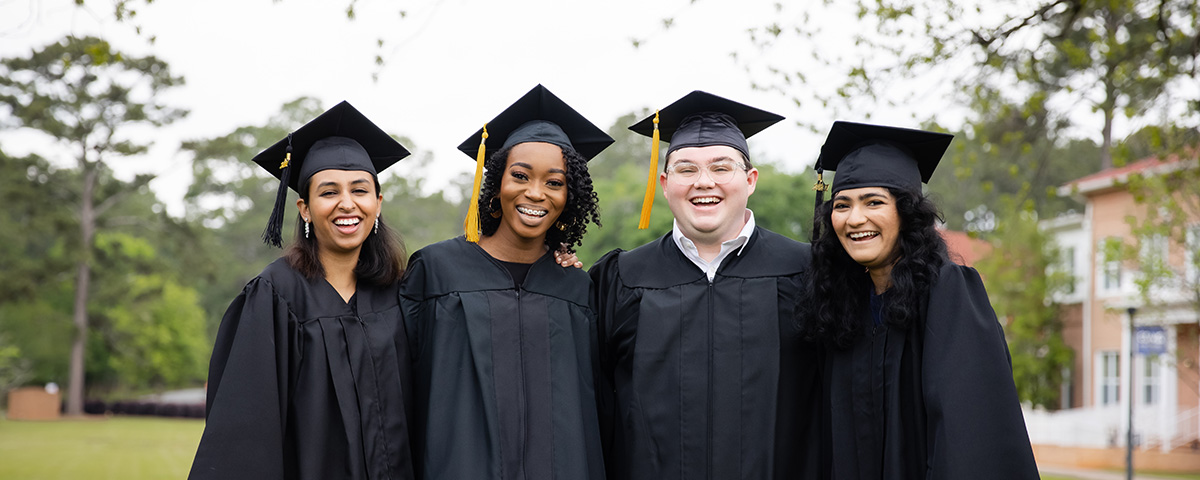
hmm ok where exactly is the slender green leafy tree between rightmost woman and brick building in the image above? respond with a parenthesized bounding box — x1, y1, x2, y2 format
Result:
(976, 198, 1074, 408)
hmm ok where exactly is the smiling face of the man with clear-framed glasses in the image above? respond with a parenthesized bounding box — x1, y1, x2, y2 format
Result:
(659, 145, 758, 245)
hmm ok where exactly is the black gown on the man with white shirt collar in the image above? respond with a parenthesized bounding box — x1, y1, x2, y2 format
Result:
(590, 228, 821, 480)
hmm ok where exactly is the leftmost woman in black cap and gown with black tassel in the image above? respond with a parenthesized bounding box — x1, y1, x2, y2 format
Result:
(190, 102, 413, 480)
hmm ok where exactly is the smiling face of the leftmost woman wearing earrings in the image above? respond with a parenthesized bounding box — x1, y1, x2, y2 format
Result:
(296, 170, 383, 257)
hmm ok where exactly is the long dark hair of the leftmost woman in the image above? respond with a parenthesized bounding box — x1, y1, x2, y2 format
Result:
(283, 175, 406, 286)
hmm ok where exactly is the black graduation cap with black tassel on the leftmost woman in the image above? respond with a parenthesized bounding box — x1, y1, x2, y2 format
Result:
(254, 101, 408, 247)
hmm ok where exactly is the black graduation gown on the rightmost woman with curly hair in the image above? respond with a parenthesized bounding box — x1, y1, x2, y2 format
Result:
(826, 262, 1038, 480)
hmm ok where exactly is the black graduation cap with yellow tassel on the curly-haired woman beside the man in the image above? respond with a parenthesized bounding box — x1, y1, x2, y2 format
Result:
(458, 85, 613, 242)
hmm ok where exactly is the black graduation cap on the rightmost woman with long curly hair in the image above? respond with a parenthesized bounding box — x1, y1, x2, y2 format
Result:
(812, 120, 954, 235)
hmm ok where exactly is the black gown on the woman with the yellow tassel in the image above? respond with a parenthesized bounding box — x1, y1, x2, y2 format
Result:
(401, 236, 604, 480)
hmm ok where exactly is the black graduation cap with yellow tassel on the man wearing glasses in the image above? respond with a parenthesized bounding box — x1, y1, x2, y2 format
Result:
(629, 90, 784, 229)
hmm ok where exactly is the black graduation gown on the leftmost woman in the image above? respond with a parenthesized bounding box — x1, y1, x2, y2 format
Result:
(188, 259, 413, 480)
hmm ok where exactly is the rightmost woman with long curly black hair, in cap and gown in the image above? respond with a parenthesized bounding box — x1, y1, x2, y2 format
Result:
(797, 121, 1038, 480)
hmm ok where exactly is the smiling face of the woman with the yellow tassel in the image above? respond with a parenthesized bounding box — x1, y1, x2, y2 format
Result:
(493, 142, 566, 248)
